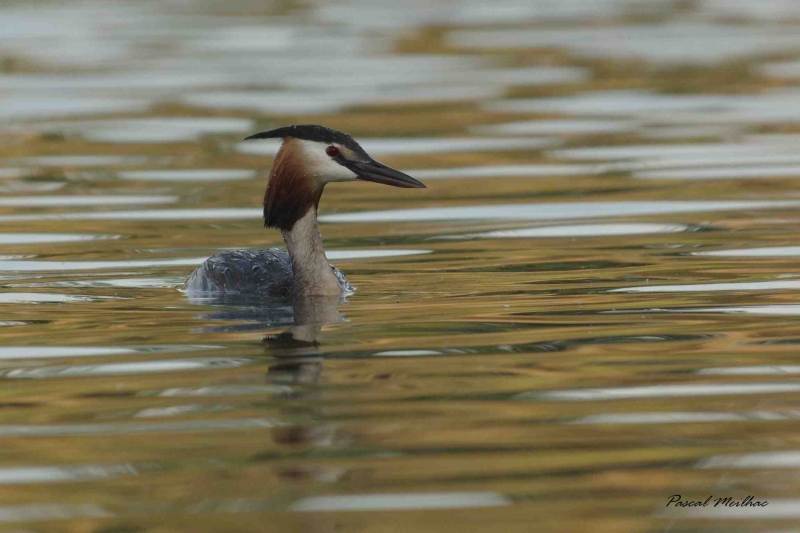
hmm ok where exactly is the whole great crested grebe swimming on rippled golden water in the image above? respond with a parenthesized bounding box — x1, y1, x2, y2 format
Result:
(185, 125, 425, 296)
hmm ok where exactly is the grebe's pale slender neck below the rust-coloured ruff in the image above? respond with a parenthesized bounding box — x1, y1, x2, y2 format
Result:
(281, 207, 342, 296)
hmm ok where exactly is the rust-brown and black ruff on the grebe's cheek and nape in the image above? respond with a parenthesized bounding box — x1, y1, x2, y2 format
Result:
(264, 138, 323, 231)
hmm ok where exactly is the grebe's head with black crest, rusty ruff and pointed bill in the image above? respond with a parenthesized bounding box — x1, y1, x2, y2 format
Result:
(245, 125, 425, 230)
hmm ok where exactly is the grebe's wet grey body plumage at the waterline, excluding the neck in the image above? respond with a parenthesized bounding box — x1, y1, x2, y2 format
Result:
(184, 248, 353, 297)
